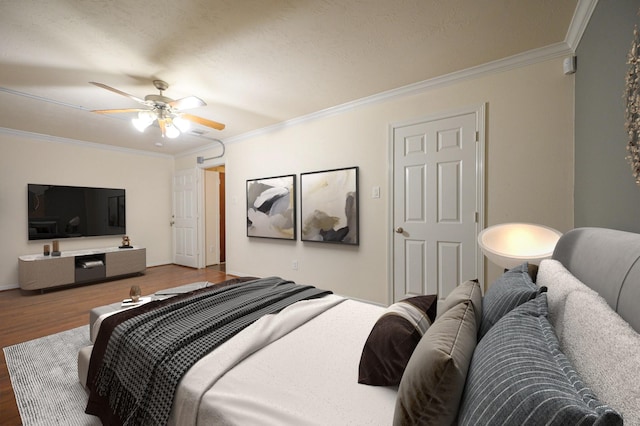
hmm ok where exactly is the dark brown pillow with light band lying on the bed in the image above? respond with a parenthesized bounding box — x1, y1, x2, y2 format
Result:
(358, 295, 438, 386)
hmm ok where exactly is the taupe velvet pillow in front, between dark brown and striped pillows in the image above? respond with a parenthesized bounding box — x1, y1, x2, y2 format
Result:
(393, 300, 478, 426)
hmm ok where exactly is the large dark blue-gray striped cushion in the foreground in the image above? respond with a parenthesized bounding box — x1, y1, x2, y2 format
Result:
(459, 293, 622, 425)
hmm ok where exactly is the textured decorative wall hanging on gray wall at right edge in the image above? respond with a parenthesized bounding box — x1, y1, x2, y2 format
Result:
(624, 20, 640, 186)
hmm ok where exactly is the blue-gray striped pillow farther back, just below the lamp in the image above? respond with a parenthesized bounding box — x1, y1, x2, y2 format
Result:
(478, 262, 540, 340)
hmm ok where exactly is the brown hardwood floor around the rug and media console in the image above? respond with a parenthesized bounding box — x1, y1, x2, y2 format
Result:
(0, 265, 233, 426)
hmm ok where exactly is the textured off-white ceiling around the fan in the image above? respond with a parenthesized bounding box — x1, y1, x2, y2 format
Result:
(0, 0, 578, 154)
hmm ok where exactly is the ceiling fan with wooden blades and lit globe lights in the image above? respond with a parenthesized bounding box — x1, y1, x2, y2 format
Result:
(89, 80, 224, 139)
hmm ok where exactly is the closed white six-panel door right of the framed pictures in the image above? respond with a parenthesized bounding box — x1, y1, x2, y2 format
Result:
(392, 106, 484, 301)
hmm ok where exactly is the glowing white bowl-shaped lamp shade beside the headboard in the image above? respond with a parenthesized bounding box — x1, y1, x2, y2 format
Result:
(478, 223, 562, 269)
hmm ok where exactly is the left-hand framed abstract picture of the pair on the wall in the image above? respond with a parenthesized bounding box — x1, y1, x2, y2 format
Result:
(247, 175, 296, 240)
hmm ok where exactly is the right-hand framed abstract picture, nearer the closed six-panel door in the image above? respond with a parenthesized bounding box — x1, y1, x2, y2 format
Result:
(300, 167, 360, 245)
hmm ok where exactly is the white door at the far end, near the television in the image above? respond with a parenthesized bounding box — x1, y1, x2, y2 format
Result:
(172, 168, 199, 268)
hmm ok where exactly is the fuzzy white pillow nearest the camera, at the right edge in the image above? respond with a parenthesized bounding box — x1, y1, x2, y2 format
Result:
(560, 291, 640, 425)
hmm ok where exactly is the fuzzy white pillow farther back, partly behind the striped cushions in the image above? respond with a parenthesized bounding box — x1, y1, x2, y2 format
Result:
(536, 259, 598, 341)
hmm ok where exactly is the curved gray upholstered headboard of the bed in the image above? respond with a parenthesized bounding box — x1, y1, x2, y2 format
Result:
(553, 228, 640, 333)
